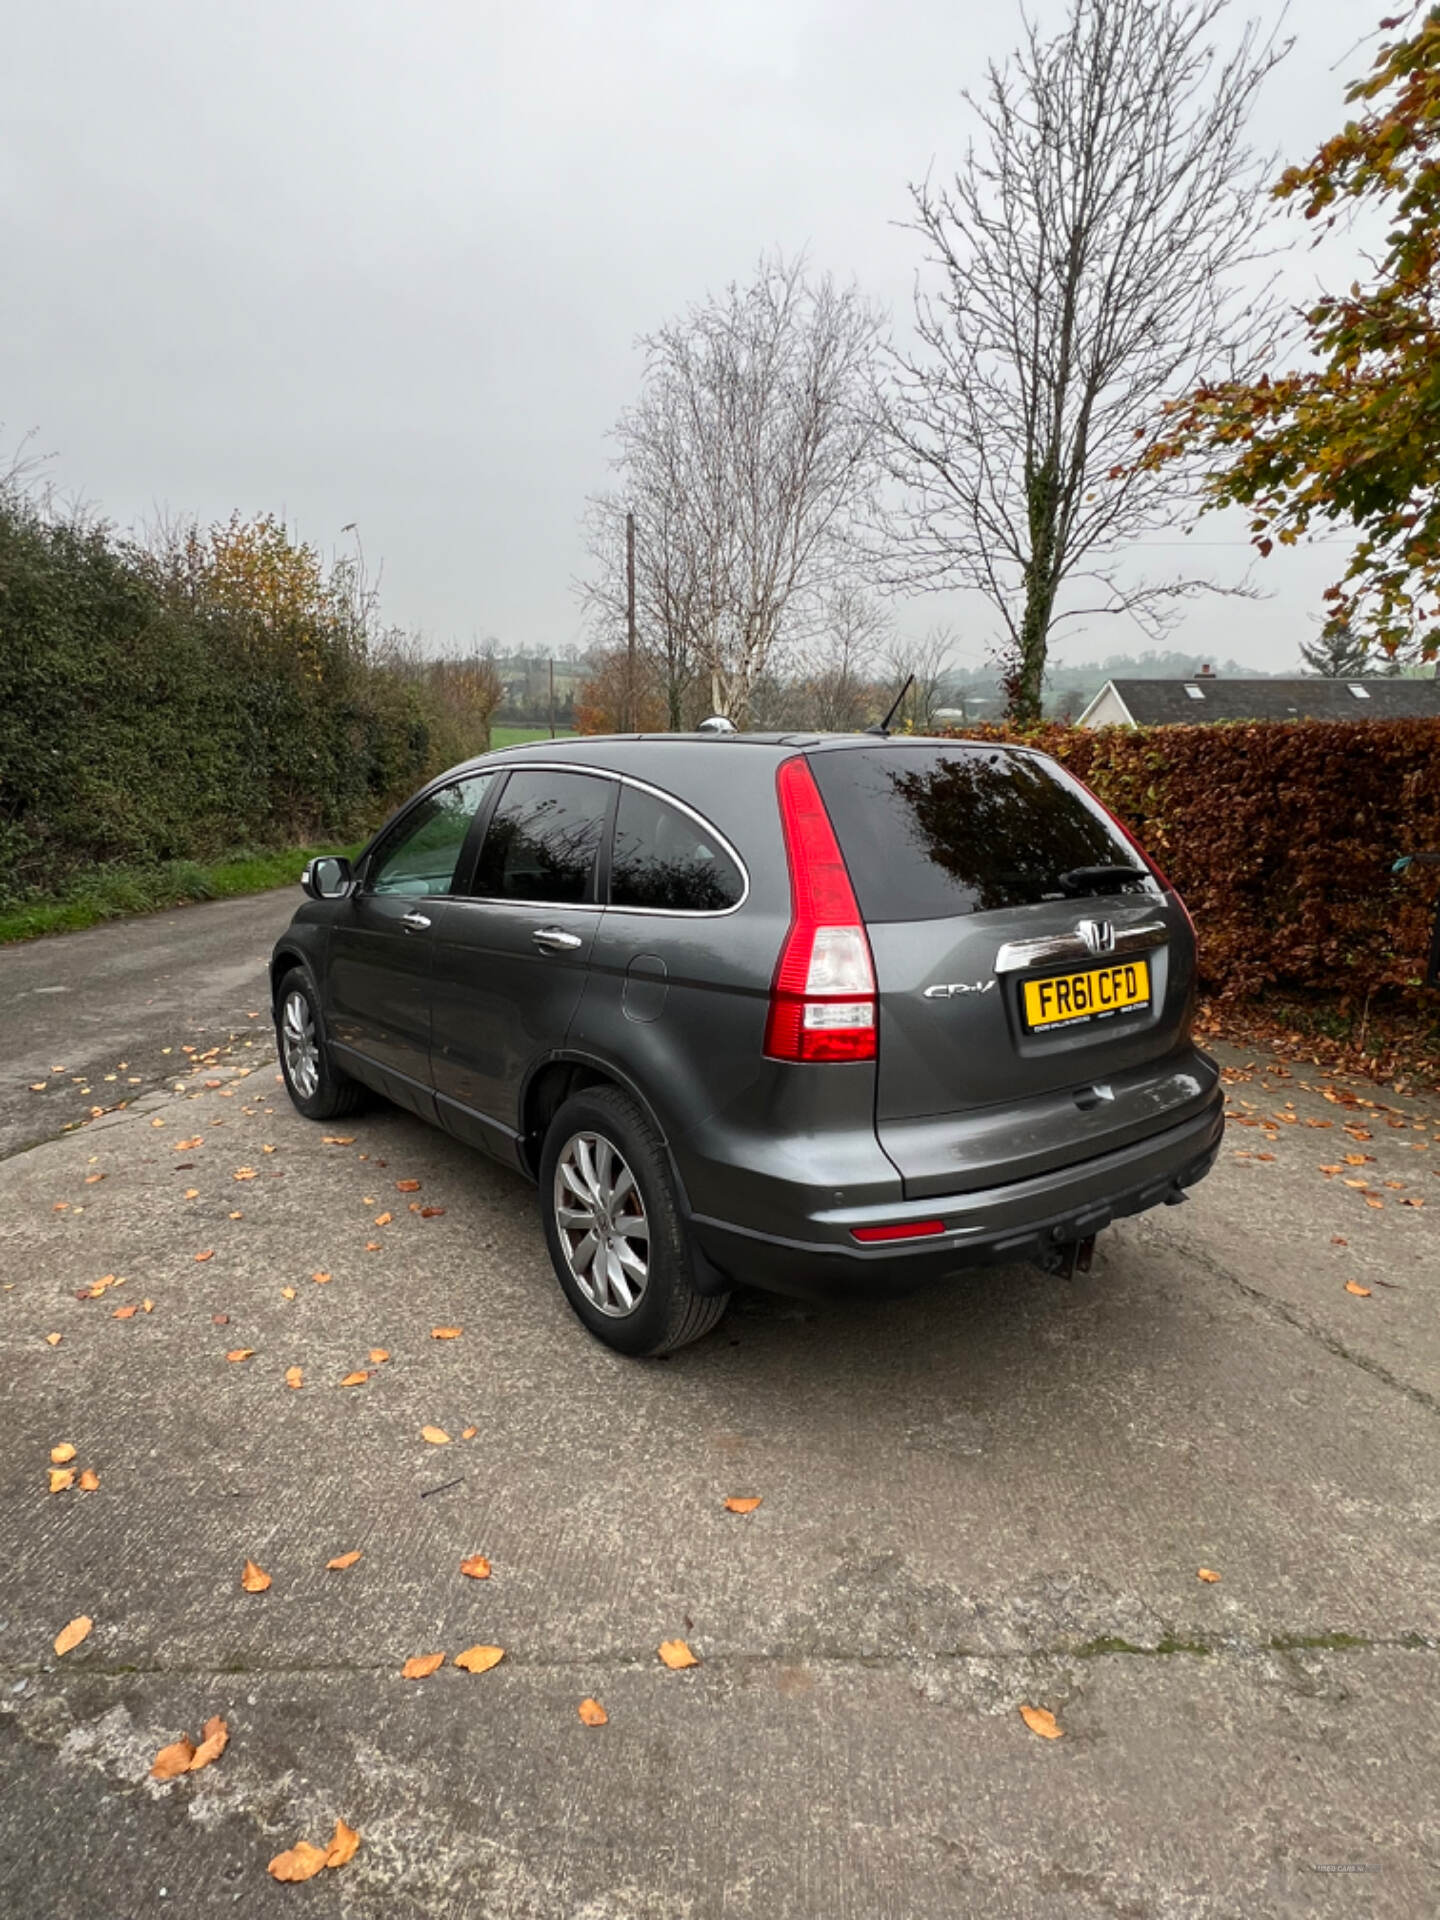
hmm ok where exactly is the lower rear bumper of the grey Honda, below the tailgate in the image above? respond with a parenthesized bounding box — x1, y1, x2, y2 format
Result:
(691, 1087, 1225, 1298)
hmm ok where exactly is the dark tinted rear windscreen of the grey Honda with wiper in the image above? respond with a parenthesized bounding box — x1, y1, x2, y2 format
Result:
(810, 743, 1152, 920)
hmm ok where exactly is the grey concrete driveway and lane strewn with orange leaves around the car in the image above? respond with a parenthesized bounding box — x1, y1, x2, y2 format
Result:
(0, 895, 1440, 1920)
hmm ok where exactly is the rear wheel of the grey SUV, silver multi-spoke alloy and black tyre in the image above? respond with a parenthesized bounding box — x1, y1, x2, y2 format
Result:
(540, 1087, 730, 1357)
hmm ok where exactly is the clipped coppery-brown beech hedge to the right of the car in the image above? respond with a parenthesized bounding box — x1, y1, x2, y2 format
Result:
(940, 720, 1440, 1000)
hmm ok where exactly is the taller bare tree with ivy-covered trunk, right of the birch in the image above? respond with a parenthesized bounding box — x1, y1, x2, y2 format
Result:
(881, 0, 1288, 722)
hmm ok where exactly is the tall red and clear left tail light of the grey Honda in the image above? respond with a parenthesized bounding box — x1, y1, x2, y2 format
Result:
(764, 756, 876, 1060)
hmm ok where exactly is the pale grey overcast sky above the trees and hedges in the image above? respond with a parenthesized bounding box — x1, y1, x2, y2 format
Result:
(0, 0, 1380, 670)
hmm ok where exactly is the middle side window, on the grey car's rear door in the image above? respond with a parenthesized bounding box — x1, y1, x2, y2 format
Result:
(474, 768, 612, 906)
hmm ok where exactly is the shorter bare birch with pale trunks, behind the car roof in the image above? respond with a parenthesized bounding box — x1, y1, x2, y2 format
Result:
(582, 255, 879, 724)
